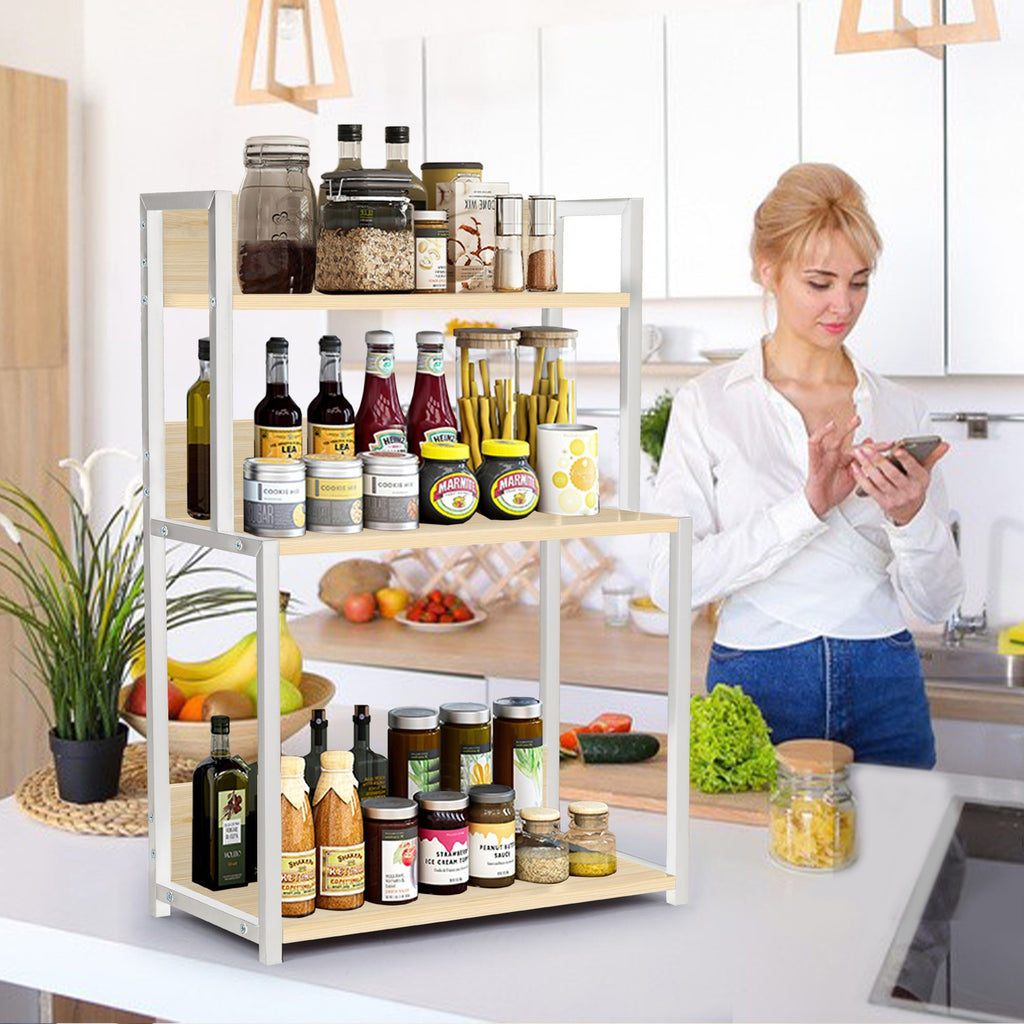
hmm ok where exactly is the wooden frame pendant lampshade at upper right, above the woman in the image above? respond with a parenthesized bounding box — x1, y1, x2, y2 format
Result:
(836, 0, 999, 56)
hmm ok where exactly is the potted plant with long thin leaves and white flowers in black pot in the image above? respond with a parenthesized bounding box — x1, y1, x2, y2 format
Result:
(0, 449, 254, 804)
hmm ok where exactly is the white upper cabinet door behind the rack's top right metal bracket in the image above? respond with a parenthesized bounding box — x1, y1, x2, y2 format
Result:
(541, 15, 666, 298)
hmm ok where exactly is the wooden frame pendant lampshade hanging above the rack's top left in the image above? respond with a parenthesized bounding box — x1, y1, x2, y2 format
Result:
(234, 0, 352, 114)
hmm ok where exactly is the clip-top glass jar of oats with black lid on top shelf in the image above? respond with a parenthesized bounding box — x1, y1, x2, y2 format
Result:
(316, 170, 416, 295)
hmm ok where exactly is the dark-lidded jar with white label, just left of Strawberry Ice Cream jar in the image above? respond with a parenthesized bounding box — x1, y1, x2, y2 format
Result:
(362, 797, 419, 906)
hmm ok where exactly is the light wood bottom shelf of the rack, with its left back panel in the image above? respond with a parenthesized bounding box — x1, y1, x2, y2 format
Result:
(171, 782, 676, 943)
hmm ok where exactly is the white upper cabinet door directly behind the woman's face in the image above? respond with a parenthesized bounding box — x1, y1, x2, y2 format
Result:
(800, 0, 945, 376)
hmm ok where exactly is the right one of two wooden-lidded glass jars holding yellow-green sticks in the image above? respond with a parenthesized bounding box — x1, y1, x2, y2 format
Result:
(516, 327, 580, 460)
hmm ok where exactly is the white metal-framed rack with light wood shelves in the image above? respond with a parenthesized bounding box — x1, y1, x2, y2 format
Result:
(139, 191, 691, 965)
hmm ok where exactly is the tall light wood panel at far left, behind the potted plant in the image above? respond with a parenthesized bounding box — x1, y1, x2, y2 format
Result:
(0, 68, 70, 797)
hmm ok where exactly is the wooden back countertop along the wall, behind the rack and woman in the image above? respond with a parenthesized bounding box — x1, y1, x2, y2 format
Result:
(289, 604, 1024, 725)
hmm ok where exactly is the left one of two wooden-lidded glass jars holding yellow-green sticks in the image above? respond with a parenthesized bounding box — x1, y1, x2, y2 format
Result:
(454, 327, 519, 472)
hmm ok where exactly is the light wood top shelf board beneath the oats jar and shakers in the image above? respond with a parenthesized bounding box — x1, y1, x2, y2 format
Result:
(164, 292, 630, 312)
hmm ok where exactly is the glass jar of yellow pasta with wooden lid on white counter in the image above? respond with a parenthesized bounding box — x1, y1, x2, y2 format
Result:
(768, 739, 857, 871)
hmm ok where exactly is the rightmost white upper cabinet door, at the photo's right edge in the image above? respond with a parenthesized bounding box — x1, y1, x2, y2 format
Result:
(946, 0, 1024, 376)
